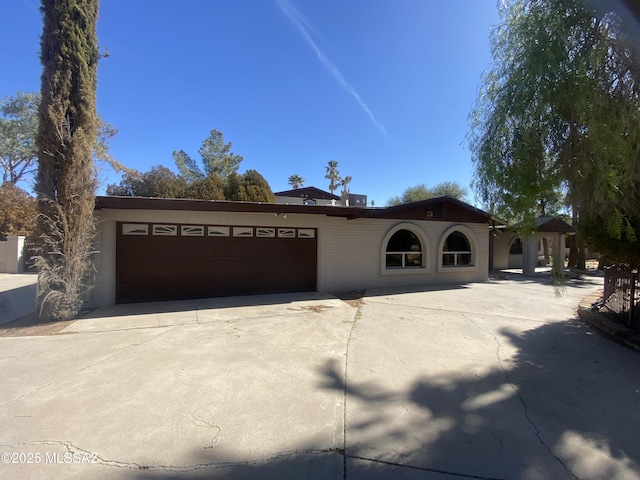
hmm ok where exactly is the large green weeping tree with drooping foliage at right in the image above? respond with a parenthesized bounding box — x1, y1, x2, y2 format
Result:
(469, 0, 640, 265)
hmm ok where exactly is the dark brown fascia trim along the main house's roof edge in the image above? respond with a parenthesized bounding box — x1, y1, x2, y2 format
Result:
(96, 196, 494, 223)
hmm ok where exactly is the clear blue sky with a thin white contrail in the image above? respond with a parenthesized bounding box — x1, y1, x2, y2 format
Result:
(0, 0, 499, 205)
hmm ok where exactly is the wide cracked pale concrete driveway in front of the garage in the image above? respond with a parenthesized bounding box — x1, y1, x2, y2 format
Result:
(0, 277, 640, 480)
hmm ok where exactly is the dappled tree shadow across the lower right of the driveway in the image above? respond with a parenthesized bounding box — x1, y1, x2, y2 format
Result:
(132, 312, 640, 480)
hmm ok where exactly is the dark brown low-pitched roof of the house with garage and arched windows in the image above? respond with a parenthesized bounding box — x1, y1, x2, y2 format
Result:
(96, 196, 493, 223)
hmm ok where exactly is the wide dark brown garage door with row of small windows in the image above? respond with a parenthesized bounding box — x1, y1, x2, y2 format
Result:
(116, 222, 317, 303)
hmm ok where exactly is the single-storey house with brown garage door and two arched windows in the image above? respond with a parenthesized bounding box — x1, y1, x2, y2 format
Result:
(90, 196, 491, 306)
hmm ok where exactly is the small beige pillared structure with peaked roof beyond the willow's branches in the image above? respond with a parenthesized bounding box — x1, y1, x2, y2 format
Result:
(491, 217, 576, 274)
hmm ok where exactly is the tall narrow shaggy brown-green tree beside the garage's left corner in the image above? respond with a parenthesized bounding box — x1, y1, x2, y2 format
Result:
(35, 0, 99, 320)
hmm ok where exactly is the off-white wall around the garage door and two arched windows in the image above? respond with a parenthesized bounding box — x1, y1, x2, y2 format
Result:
(91, 209, 489, 306)
